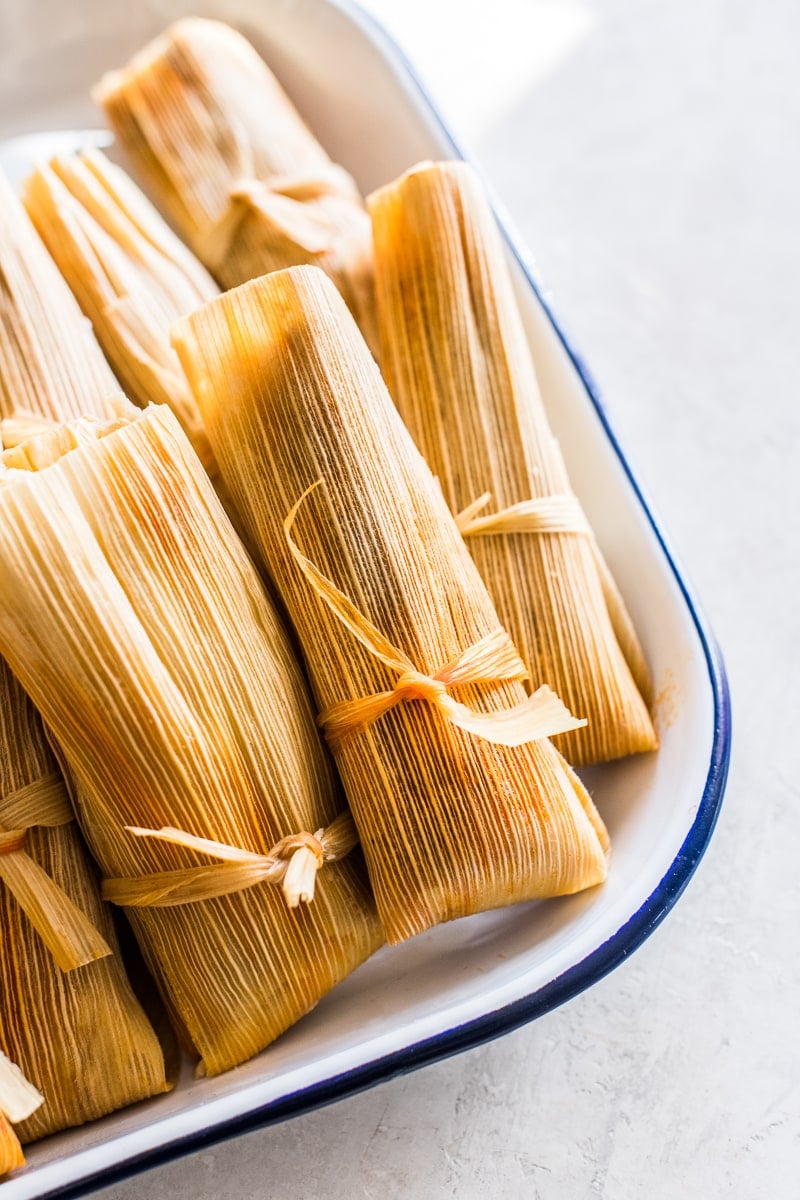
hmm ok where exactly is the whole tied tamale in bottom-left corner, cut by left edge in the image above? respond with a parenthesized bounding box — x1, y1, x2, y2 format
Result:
(0, 661, 168, 1141)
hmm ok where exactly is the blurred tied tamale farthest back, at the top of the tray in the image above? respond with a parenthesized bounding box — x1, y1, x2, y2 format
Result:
(95, 18, 375, 344)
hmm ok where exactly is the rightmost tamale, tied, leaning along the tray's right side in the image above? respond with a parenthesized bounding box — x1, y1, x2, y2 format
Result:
(369, 162, 657, 764)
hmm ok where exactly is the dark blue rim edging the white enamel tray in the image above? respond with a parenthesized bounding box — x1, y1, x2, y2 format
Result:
(31, 0, 730, 1200)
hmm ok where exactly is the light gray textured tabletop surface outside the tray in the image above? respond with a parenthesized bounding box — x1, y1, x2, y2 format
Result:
(86, 0, 800, 1200)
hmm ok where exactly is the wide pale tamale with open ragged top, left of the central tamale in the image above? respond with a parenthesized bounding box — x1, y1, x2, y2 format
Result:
(0, 404, 383, 1074)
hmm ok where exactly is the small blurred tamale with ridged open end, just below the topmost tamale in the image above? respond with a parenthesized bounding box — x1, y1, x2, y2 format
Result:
(23, 150, 217, 473)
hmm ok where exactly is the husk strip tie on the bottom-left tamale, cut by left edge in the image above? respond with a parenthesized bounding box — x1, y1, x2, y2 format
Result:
(0, 774, 112, 971)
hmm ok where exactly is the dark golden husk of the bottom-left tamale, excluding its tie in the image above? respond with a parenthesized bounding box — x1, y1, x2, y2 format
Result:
(0, 661, 168, 1141)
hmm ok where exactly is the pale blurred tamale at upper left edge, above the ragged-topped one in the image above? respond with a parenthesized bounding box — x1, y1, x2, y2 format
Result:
(0, 173, 120, 424)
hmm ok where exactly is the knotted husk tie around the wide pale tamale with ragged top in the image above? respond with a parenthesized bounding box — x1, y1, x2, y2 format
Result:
(103, 812, 359, 908)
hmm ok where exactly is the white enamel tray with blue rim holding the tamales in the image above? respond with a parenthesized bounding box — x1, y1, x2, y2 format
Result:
(0, 0, 730, 1200)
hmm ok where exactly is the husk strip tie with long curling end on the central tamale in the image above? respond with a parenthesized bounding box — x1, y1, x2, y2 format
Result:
(283, 480, 587, 754)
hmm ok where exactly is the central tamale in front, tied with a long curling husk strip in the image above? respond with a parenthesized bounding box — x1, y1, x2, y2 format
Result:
(173, 268, 608, 942)
